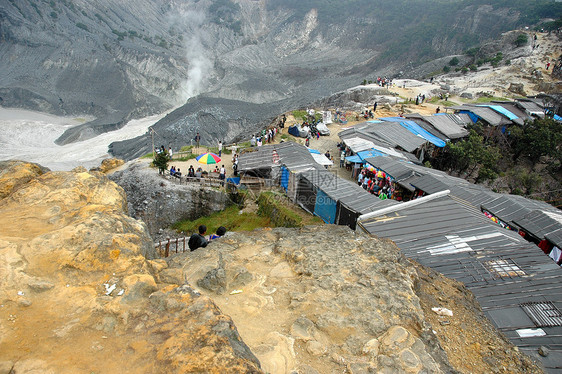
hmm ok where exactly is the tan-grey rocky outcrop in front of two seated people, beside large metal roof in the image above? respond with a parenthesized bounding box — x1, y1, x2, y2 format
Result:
(167, 225, 540, 374)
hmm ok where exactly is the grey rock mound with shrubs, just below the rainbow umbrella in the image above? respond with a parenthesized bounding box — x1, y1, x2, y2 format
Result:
(109, 159, 232, 237)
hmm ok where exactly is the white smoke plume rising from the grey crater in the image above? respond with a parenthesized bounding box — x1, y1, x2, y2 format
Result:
(176, 10, 213, 102)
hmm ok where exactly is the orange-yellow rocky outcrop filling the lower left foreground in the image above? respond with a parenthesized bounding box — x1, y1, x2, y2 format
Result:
(0, 164, 261, 374)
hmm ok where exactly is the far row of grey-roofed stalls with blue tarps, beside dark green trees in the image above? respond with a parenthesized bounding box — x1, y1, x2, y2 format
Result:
(338, 98, 547, 169)
